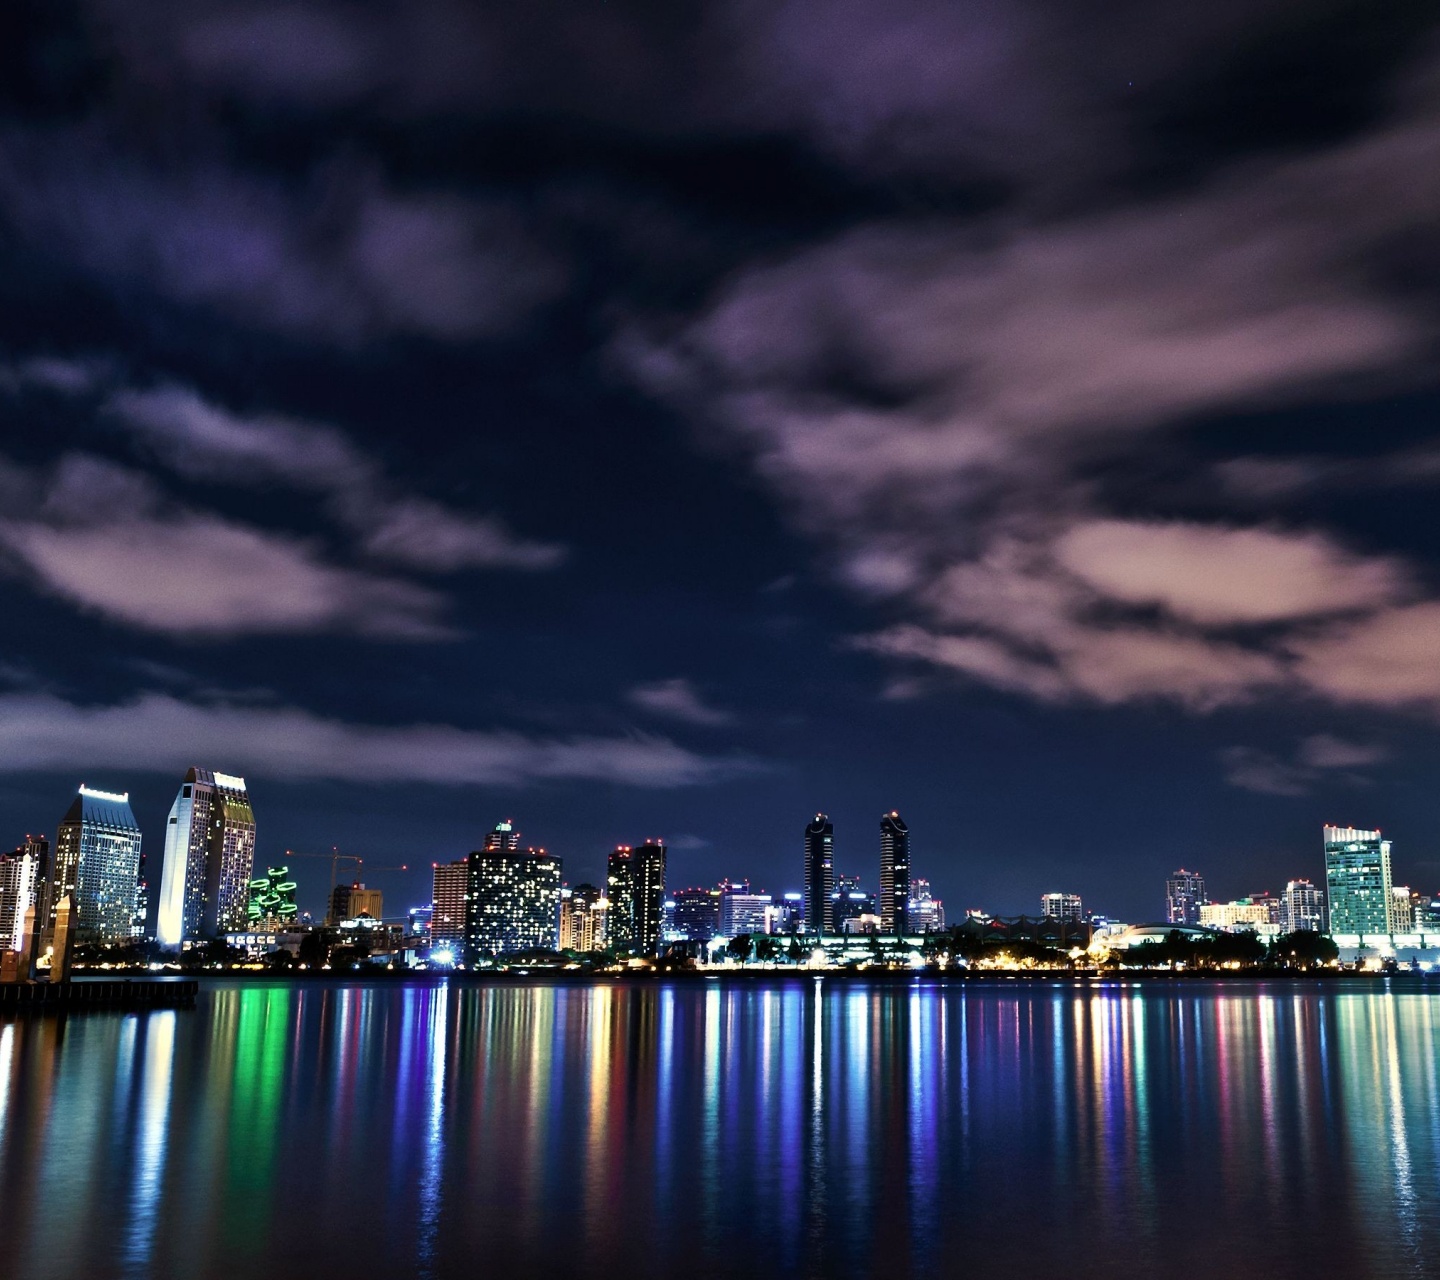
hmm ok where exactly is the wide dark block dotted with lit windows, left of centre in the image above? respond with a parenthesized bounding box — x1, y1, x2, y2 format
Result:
(465, 849, 560, 963)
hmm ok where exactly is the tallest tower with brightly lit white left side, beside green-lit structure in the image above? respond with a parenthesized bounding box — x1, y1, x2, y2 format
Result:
(156, 769, 255, 946)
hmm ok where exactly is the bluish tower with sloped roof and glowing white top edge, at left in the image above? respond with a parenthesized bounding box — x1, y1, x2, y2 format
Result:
(45, 786, 140, 946)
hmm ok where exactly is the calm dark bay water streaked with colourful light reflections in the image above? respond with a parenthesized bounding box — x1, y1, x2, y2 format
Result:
(0, 981, 1440, 1280)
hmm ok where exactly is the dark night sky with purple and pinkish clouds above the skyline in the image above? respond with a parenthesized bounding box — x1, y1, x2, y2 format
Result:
(0, 0, 1440, 920)
